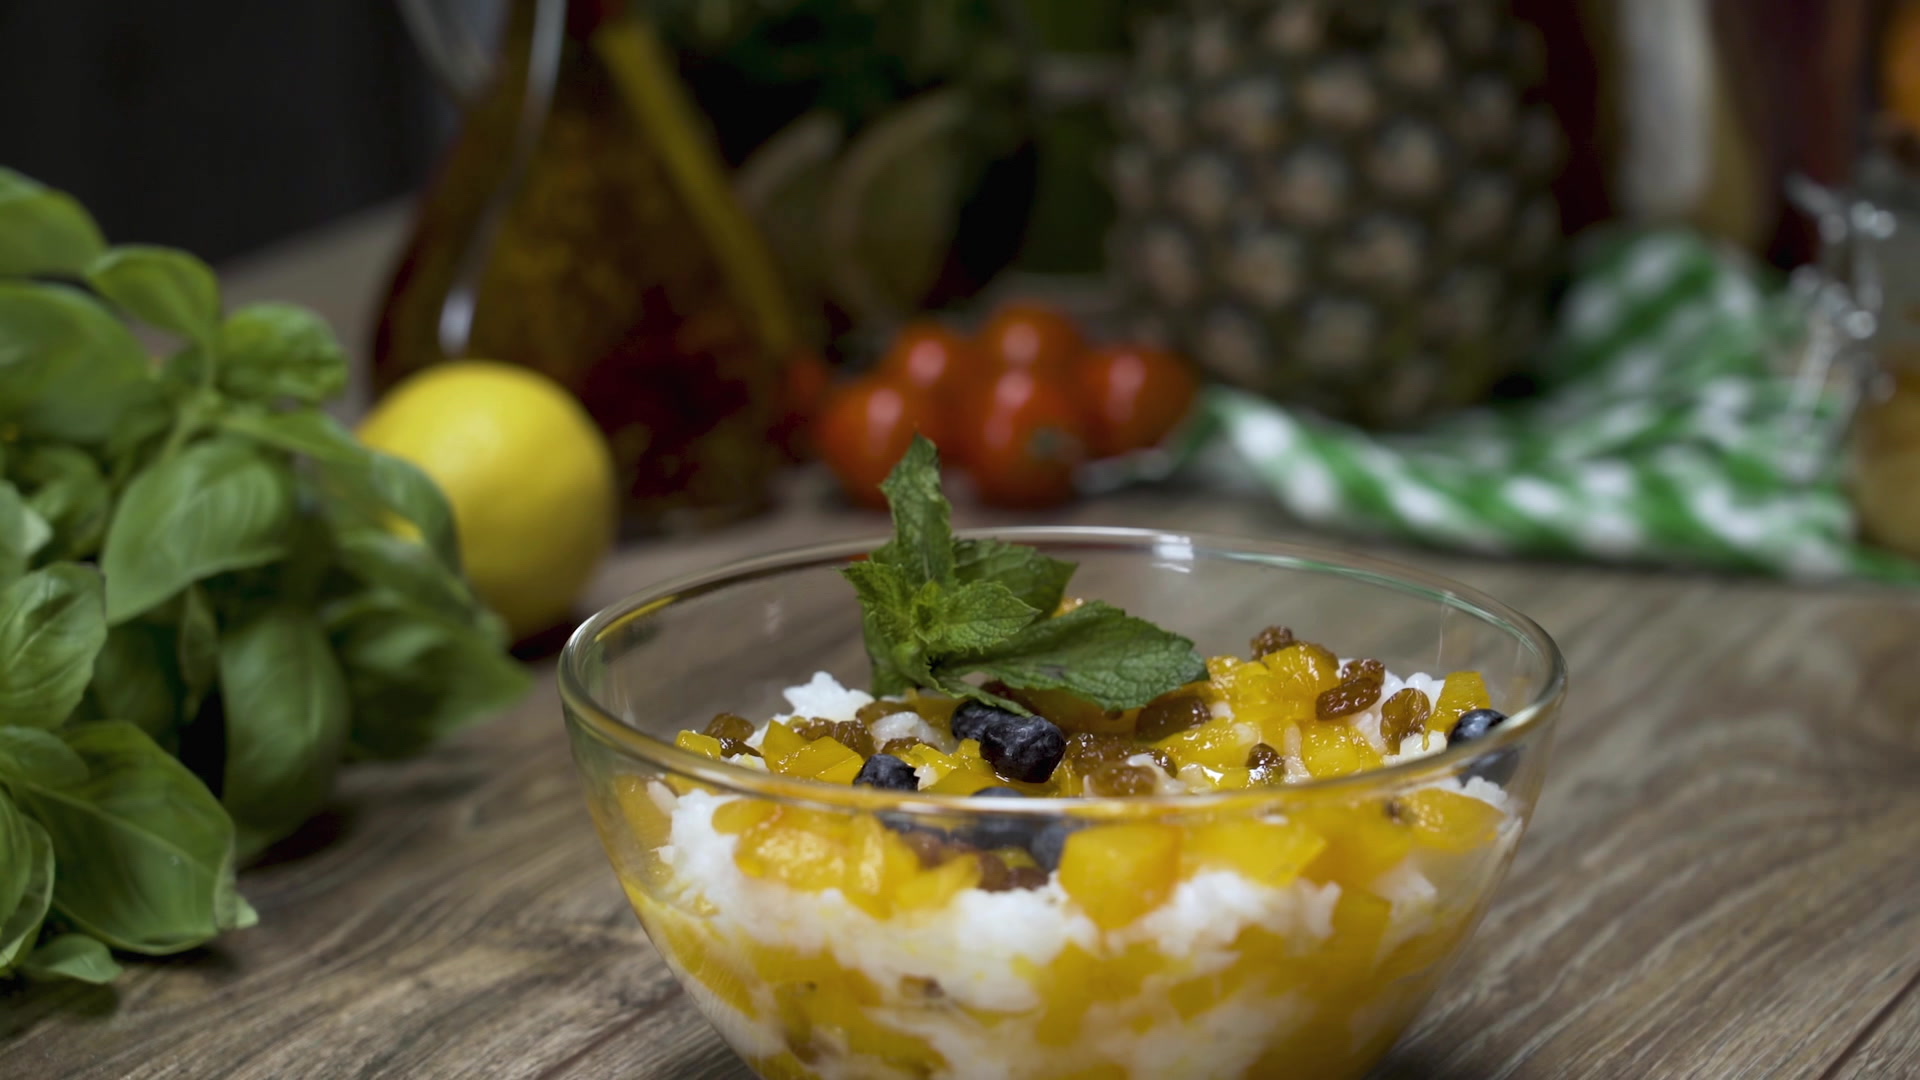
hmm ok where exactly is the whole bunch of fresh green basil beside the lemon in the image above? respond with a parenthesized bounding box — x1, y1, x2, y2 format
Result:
(0, 169, 528, 976)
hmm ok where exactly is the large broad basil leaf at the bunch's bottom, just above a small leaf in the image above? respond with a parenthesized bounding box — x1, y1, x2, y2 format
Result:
(13, 723, 257, 955)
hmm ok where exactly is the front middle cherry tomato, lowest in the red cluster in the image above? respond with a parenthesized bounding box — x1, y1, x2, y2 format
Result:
(962, 369, 1087, 507)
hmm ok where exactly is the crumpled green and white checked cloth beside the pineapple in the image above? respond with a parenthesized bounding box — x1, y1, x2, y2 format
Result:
(1098, 233, 1920, 582)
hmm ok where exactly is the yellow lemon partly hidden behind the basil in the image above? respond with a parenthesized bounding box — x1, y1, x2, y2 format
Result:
(359, 359, 616, 638)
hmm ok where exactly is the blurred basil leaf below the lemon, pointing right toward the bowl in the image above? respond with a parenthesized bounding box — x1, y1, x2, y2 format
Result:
(328, 596, 532, 757)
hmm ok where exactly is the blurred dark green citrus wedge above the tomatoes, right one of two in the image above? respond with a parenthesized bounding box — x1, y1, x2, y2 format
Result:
(822, 86, 968, 321)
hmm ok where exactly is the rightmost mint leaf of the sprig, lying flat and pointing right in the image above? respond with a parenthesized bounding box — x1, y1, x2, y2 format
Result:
(943, 601, 1206, 709)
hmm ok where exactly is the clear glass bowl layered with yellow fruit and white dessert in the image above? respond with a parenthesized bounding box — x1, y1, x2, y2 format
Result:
(561, 528, 1565, 1080)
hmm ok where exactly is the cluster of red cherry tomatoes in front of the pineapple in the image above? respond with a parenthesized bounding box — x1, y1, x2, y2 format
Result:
(812, 302, 1196, 507)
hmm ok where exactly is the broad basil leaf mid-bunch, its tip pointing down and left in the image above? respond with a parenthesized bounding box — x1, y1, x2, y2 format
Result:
(100, 440, 294, 623)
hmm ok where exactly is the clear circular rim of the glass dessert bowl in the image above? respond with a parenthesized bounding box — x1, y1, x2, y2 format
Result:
(559, 527, 1567, 817)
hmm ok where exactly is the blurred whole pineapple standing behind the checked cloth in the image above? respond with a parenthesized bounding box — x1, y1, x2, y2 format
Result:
(1108, 0, 1561, 427)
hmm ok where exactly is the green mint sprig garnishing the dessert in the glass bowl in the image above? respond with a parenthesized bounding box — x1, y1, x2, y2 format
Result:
(843, 436, 1206, 711)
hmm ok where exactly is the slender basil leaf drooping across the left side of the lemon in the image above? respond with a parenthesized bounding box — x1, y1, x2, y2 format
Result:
(221, 409, 461, 573)
